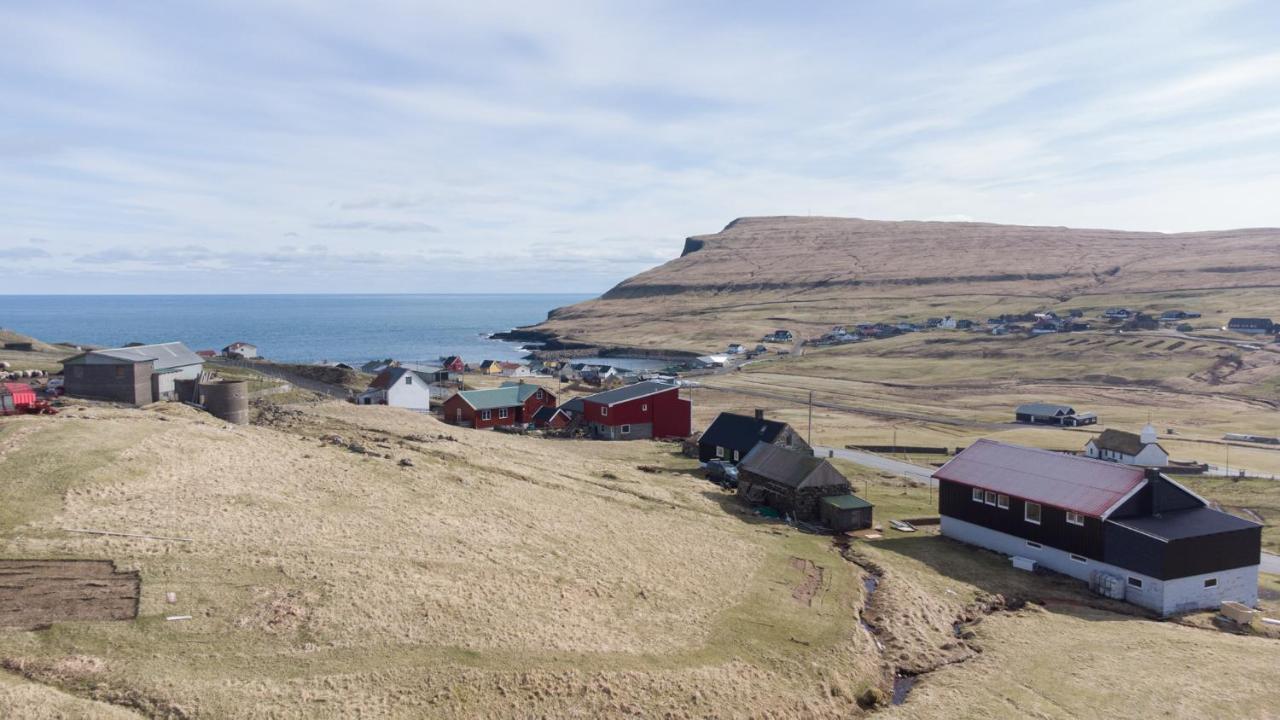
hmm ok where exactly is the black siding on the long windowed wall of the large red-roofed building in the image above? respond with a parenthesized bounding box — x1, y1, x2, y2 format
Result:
(938, 480, 1103, 560)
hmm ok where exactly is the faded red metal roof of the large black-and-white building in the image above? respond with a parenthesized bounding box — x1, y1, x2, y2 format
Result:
(933, 439, 1146, 518)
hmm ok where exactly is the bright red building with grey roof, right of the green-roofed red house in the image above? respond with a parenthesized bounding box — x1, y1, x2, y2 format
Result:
(582, 380, 694, 439)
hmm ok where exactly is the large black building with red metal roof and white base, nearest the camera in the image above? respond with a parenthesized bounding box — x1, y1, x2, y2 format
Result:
(933, 439, 1262, 615)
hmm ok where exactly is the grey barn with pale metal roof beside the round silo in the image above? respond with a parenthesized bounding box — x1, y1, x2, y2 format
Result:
(63, 342, 205, 405)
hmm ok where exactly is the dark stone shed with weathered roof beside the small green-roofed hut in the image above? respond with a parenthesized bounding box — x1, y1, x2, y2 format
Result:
(737, 442, 870, 525)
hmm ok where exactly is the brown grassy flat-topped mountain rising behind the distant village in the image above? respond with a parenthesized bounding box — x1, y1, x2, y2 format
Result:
(517, 217, 1280, 350)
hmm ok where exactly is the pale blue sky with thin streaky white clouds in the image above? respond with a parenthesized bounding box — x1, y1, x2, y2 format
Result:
(0, 0, 1280, 293)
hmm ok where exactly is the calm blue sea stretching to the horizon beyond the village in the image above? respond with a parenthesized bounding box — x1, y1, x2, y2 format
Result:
(0, 295, 590, 363)
